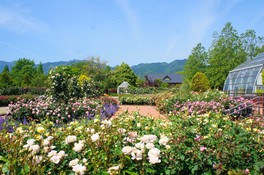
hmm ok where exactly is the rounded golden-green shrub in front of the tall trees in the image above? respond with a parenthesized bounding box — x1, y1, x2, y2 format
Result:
(191, 72, 210, 92)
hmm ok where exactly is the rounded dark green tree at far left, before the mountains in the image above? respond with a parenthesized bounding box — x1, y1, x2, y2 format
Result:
(11, 58, 36, 87)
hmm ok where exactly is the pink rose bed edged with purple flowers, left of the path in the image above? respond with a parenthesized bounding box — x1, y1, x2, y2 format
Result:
(5, 96, 118, 124)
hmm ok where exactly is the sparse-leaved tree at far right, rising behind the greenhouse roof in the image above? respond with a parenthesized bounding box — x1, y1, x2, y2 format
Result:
(241, 30, 264, 60)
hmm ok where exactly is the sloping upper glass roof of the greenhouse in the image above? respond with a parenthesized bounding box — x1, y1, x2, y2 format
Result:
(230, 52, 264, 72)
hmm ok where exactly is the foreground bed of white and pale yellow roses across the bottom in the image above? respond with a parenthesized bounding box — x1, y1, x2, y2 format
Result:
(0, 113, 264, 174)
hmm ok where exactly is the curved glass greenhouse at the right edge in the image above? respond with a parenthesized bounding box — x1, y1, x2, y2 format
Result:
(223, 53, 264, 93)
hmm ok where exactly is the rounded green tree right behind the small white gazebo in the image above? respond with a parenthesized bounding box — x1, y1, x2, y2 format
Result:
(110, 62, 137, 88)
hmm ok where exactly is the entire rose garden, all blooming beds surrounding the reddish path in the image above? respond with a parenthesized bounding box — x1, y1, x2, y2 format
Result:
(0, 65, 264, 175)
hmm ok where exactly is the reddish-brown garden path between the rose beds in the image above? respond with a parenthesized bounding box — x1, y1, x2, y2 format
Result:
(112, 105, 168, 120)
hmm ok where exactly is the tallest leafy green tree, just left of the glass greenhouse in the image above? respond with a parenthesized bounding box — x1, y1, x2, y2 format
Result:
(207, 22, 247, 89)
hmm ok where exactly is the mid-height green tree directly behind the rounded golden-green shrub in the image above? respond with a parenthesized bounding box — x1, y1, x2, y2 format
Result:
(184, 43, 207, 80)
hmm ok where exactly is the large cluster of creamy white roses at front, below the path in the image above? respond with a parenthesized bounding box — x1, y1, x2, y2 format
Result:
(122, 135, 169, 164)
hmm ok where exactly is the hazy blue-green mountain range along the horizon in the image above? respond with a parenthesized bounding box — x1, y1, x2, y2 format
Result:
(0, 59, 186, 77)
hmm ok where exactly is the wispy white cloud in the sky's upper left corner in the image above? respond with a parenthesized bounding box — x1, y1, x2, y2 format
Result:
(0, 7, 46, 33)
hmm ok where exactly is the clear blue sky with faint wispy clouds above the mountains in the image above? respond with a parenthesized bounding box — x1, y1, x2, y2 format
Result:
(0, 0, 264, 66)
